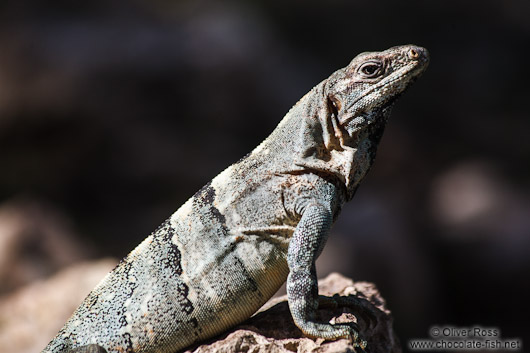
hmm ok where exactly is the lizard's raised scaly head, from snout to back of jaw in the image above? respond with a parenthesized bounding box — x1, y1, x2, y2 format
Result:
(325, 45, 429, 143)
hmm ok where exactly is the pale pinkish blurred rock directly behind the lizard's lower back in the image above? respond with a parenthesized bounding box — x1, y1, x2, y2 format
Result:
(0, 259, 117, 353)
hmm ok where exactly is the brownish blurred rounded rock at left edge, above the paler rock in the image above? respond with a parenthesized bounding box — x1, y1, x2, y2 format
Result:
(0, 198, 94, 294)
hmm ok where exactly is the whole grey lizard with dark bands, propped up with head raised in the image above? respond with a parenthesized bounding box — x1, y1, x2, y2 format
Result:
(42, 45, 429, 353)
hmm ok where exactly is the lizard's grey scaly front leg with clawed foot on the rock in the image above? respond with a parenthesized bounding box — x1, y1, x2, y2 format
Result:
(287, 202, 366, 349)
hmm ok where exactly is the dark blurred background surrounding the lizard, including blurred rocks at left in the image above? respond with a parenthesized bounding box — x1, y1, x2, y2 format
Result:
(0, 0, 530, 352)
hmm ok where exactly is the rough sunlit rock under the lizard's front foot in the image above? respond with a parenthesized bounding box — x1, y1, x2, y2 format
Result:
(186, 273, 401, 353)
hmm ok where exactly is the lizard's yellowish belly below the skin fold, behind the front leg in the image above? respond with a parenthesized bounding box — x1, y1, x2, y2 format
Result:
(170, 219, 289, 343)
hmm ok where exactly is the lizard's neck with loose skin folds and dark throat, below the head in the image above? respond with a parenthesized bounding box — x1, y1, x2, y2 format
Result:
(251, 81, 389, 199)
